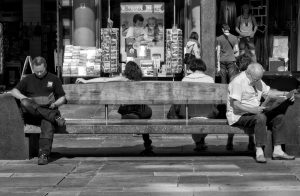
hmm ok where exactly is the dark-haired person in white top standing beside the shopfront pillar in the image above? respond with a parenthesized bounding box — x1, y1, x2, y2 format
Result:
(184, 32, 201, 70)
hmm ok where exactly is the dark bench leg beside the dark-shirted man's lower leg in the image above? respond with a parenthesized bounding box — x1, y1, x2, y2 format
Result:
(25, 133, 40, 159)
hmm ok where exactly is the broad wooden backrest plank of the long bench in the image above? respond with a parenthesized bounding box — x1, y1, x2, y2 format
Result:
(63, 81, 227, 104)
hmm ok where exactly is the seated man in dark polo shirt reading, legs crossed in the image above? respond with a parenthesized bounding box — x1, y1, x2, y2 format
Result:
(11, 57, 66, 165)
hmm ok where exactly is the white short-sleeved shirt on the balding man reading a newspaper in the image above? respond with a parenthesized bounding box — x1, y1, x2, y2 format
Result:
(226, 71, 270, 125)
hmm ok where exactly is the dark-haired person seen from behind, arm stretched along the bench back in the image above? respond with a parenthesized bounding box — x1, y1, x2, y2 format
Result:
(76, 61, 154, 156)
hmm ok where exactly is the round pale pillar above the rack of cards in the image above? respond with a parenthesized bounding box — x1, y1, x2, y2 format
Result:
(73, 0, 96, 46)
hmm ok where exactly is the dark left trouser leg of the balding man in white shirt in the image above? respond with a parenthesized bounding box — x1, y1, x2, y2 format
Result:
(234, 113, 267, 147)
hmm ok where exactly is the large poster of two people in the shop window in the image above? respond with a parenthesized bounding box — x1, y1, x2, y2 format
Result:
(120, 3, 165, 66)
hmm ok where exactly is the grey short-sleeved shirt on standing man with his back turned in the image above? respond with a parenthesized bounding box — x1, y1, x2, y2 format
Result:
(217, 34, 238, 62)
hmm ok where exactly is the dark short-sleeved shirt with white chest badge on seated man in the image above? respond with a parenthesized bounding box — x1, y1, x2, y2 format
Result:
(15, 73, 65, 105)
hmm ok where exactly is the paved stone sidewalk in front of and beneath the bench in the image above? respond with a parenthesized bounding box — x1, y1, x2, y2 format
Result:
(0, 135, 300, 196)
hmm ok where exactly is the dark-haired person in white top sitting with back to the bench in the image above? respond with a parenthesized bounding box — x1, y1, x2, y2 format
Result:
(167, 59, 218, 152)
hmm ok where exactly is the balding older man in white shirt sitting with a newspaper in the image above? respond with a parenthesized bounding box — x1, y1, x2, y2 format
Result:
(226, 63, 295, 163)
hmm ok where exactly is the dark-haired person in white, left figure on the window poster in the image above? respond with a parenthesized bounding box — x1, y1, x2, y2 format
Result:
(126, 14, 146, 41)
